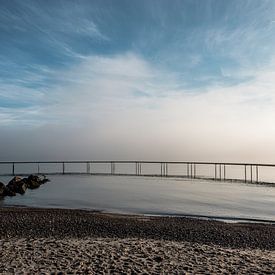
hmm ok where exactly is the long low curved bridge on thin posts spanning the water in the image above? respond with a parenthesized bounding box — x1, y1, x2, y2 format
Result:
(0, 160, 275, 183)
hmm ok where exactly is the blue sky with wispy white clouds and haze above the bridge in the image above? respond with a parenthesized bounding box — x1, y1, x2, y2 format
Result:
(0, 0, 275, 163)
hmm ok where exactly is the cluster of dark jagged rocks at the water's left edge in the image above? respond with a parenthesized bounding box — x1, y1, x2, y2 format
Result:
(0, 175, 49, 197)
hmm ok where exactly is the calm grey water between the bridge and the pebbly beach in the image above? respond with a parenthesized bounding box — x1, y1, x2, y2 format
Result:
(0, 175, 275, 221)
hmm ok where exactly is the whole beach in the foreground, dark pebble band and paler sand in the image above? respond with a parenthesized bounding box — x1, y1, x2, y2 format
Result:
(0, 207, 275, 274)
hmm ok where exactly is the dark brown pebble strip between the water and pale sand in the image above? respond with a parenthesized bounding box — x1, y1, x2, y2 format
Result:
(0, 207, 275, 250)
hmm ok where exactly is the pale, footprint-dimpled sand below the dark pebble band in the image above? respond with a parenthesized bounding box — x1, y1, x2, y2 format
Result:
(0, 238, 275, 274)
